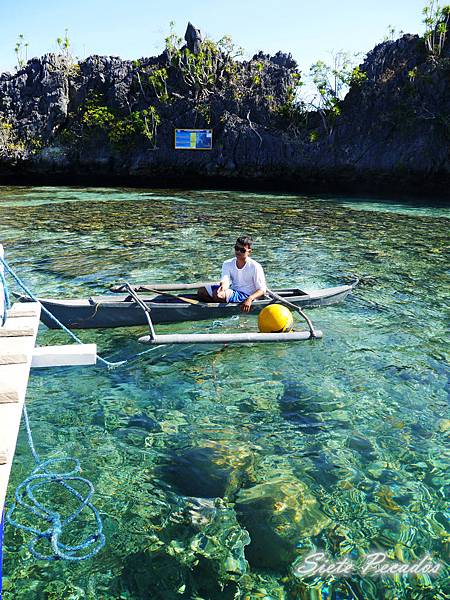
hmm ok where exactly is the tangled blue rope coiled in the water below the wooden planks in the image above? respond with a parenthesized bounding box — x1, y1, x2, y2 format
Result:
(6, 405, 106, 561)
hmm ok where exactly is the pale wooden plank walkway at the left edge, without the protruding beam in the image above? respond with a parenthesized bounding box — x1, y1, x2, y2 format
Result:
(0, 302, 41, 514)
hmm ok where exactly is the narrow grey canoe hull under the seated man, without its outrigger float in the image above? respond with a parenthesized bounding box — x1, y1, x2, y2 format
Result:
(14, 281, 357, 329)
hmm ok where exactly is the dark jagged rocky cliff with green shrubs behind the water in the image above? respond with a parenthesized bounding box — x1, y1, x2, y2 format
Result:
(0, 26, 450, 195)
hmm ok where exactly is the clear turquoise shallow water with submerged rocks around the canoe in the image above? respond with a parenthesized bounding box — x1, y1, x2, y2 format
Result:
(0, 188, 450, 600)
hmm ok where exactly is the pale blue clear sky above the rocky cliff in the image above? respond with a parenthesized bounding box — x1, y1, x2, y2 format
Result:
(0, 0, 426, 72)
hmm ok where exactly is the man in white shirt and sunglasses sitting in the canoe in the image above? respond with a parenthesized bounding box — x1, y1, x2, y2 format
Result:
(198, 235, 267, 312)
